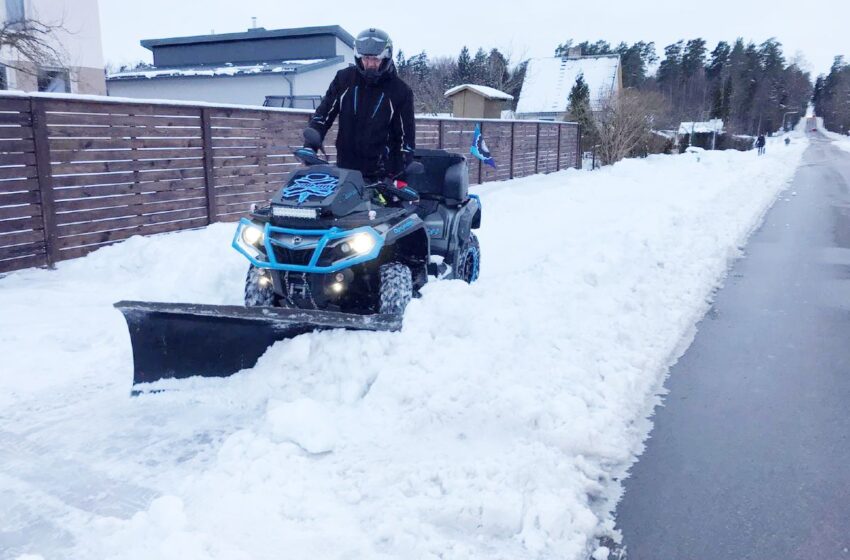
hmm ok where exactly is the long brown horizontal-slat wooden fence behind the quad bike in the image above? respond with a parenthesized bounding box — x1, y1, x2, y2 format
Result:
(0, 95, 581, 273)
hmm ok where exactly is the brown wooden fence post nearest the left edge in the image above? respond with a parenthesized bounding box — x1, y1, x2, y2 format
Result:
(30, 98, 59, 268)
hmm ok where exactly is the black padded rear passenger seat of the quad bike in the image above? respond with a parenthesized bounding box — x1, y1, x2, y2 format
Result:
(407, 149, 469, 205)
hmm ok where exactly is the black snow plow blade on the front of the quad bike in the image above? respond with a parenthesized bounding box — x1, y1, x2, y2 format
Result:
(115, 301, 401, 385)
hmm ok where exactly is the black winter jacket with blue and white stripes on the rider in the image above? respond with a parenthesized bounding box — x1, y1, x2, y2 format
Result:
(310, 66, 416, 177)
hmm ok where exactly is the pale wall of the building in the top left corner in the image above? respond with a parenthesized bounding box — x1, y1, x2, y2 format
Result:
(0, 0, 106, 94)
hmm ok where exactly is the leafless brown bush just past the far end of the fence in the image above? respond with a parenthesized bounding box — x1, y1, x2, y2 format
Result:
(594, 89, 666, 165)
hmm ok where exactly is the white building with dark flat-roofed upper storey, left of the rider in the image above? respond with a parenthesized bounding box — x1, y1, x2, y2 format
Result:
(106, 25, 354, 109)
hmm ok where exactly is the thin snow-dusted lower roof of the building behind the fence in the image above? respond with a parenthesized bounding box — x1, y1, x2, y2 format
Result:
(106, 56, 343, 80)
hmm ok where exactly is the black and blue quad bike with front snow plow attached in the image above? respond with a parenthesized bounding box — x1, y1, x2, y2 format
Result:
(115, 133, 481, 384)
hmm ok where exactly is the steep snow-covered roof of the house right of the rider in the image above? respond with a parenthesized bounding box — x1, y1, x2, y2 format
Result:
(516, 55, 620, 114)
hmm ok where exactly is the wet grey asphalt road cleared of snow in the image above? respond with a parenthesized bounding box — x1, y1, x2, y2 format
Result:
(617, 133, 850, 560)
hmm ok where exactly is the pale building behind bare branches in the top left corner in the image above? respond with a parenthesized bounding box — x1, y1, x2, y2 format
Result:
(0, 0, 106, 95)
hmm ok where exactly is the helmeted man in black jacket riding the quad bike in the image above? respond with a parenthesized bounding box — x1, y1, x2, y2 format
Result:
(304, 28, 416, 199)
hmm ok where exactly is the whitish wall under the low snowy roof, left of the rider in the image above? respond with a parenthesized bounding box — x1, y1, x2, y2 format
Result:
(108, 64, 347, 105)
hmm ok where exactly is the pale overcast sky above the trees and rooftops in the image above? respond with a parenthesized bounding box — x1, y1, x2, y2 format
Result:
(100, 0, 850, 74)
